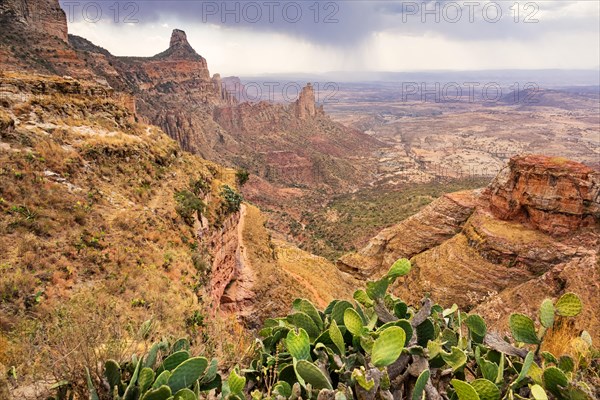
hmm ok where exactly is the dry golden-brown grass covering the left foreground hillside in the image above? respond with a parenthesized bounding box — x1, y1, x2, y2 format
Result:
(0, 76, 243, 398)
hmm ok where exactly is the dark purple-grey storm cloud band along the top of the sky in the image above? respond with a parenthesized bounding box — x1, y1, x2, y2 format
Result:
(61, 0, 597, 46)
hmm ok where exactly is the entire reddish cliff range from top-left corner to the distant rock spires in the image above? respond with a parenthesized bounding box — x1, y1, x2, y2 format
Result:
(0, 0, 379, 189)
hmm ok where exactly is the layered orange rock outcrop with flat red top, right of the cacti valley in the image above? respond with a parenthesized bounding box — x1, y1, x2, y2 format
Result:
(338, 155, 600, 338)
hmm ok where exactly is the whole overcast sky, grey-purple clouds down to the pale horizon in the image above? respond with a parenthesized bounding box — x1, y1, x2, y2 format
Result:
(61, 0, 600, 76)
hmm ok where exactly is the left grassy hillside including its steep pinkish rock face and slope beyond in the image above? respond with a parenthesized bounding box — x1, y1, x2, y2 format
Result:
(0, 69, 352, 398)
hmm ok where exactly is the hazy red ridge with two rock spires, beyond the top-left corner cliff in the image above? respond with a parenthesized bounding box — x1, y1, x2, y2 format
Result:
(65, 29, 380, 188)
